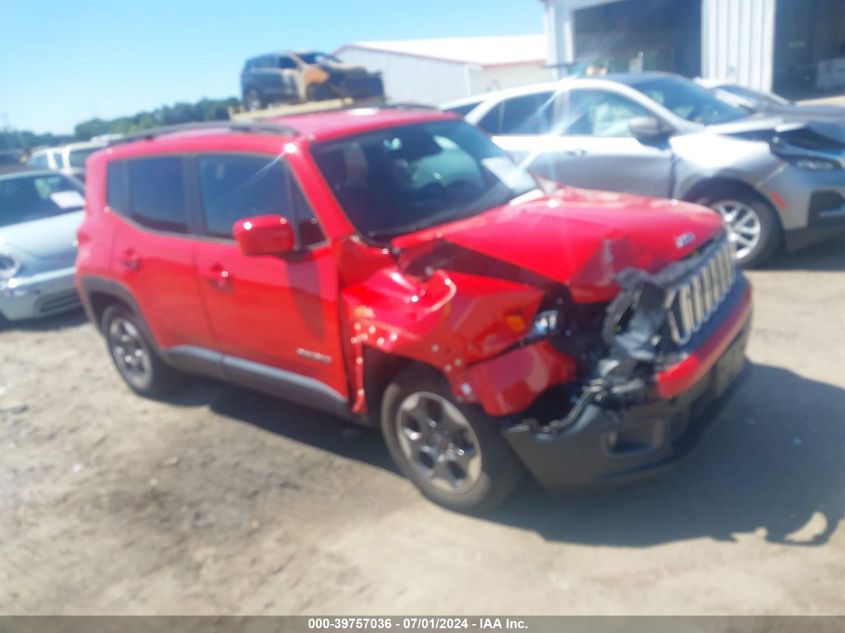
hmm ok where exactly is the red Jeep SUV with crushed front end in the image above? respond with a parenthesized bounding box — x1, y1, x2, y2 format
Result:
(77, 108, 751, 511)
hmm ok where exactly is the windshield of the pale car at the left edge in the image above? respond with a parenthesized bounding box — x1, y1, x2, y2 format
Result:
(0, 174, 85, 226)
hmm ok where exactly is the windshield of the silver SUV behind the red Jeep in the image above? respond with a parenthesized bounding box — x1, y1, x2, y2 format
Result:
(631, 77, 747, 125)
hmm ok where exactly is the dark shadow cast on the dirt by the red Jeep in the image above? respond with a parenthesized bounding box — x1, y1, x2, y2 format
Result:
(173, 365, 845, 547)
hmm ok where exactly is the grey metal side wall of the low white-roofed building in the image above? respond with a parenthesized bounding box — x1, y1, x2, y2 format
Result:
(332, 47, 472, 105)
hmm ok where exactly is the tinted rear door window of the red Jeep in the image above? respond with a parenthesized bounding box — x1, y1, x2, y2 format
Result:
(128, 156, 188, 233)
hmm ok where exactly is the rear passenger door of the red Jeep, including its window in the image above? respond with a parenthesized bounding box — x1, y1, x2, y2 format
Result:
(107, 155, 211, 347)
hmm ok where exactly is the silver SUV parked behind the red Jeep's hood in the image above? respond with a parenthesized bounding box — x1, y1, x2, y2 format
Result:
(443, 73, 845, 266)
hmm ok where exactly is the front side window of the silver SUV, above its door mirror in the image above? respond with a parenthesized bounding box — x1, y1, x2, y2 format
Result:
(561, 90, 650, 137)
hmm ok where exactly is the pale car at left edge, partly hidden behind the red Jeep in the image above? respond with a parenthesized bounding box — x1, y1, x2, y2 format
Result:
(0, 165, 85, 321)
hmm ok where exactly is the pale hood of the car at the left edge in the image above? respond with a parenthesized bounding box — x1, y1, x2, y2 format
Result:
(0, 211, 84, 265)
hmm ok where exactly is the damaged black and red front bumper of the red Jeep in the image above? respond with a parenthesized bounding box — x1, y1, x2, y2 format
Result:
(505, 276, 751, 489)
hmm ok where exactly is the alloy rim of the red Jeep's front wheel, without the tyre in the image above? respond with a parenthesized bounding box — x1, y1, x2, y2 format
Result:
(395, 392, 481, 493)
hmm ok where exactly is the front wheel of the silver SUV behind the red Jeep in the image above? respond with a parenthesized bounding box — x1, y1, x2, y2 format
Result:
(703, 192, 781, 268)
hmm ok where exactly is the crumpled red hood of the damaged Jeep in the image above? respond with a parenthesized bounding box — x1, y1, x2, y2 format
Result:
(394, 188, 722, 301)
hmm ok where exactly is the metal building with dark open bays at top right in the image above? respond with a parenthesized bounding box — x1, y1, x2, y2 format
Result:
(541, 0, 845, 97)
